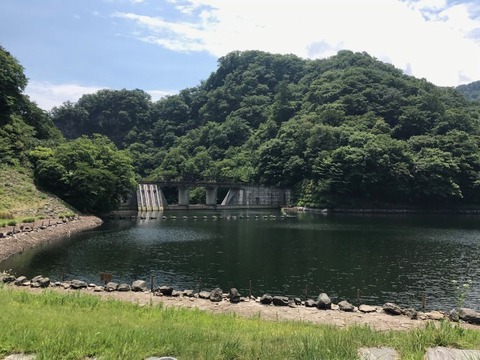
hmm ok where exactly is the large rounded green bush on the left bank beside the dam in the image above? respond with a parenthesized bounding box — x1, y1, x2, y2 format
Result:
(31, 135, 135, 213)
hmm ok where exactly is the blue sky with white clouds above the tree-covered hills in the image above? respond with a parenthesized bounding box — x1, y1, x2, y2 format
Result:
(0, 0, 480, 111)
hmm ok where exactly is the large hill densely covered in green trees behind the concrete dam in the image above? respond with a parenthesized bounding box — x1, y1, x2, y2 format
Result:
(51, 51, 480, 207)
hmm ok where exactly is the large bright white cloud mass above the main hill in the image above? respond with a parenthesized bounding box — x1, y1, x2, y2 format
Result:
(113, 0, 480, 85)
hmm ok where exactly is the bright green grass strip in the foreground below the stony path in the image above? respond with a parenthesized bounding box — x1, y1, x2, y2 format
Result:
(0, 286, 480, 360)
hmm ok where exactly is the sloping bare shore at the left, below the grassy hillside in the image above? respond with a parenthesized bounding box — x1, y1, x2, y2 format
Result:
(0, 215, 103, 262)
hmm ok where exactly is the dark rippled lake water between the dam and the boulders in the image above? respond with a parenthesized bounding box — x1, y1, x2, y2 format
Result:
(0, 210, 480, 310)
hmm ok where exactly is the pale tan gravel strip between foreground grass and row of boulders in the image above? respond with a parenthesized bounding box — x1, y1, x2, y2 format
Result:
(4, 284, 480, 331)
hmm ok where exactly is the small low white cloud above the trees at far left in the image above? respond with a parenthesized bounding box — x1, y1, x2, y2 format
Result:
(25, 81, 104, 111)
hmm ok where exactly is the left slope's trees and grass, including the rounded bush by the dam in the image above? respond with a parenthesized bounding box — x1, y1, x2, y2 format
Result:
(0, 46, 135, 217)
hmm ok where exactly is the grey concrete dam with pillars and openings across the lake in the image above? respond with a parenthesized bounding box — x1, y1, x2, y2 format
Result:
(133, 182, 291, 211)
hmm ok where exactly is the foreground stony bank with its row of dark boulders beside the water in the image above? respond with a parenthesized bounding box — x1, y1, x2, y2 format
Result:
(0, 274, 480, 330)
